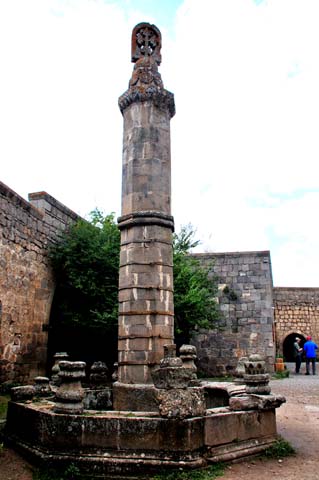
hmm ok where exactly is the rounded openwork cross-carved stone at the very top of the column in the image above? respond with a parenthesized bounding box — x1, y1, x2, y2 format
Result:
(132, 23, 162, 65)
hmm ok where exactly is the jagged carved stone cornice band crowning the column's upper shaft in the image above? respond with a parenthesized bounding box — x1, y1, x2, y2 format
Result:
(119, 85, 175, 118)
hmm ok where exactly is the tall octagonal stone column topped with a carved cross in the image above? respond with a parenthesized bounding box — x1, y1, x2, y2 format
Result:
(114, 23, 175, 410)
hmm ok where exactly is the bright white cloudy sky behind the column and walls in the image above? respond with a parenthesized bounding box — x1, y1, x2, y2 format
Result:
(0, 0, 319, 287)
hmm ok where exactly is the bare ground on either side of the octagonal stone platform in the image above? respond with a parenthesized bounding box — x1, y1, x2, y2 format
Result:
(0, 375, 319, 480)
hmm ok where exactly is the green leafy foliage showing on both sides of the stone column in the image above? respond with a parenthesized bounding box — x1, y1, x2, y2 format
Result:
(50, 210, 218, 342)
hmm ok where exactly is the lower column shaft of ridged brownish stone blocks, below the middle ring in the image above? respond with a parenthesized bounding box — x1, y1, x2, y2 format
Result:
(118, 165, 174, 383)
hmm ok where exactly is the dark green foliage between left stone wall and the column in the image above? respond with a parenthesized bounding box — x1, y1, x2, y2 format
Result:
(50, 210, 120, 328)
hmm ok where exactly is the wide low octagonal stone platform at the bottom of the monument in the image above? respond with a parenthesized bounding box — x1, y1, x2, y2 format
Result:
(5, 401, 277, 480)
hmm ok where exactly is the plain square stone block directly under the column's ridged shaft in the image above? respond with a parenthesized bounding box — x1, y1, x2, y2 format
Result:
(113, 382, 158, 413)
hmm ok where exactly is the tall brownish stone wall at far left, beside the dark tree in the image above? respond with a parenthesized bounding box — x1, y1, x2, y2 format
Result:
(0, 182, 78, 383)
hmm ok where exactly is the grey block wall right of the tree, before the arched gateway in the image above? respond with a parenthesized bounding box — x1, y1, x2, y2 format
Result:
(192, 251, 275, 376)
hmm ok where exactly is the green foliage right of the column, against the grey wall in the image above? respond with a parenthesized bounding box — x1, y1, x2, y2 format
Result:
(173, 225, 220, 344)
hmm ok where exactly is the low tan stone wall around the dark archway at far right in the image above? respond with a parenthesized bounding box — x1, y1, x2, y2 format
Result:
(273, 287, 319, 354)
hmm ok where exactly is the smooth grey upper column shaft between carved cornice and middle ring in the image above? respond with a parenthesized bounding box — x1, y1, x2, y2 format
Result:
(122, 101, 171, 215)
